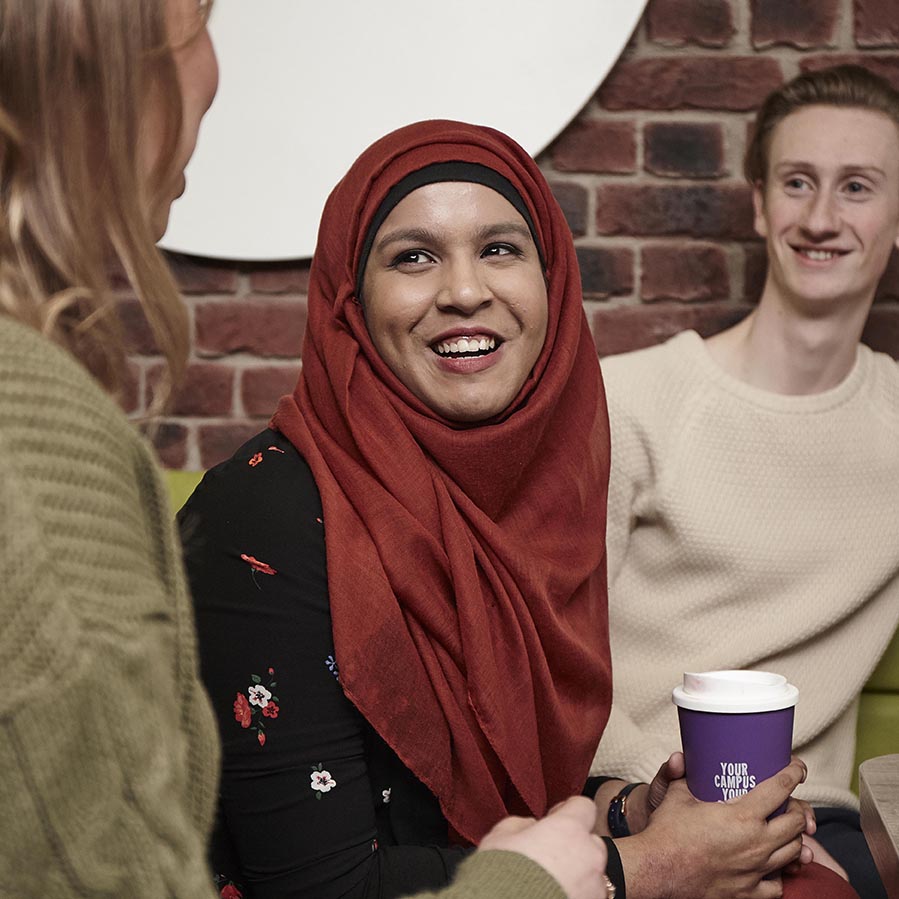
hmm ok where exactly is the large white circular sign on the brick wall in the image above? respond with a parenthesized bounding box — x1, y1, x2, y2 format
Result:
(161, 0, 645, 260)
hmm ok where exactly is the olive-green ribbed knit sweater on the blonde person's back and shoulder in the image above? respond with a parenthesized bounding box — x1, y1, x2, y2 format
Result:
(0, 316, 218, 899)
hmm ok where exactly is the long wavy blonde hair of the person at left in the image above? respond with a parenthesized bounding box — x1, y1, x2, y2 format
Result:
(0, 0, 204, 411)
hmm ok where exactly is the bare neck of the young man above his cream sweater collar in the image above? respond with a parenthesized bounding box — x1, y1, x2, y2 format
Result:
(706, 288, 870, 395)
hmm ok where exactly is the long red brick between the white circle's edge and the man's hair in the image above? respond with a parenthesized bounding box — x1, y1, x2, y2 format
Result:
(598, 56, 783, 112)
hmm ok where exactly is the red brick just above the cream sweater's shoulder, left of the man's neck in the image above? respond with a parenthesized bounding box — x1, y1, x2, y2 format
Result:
(593, 303, 751, 356)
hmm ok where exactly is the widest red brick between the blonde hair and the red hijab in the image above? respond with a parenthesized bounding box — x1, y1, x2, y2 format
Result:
(194, 297, 306, 359)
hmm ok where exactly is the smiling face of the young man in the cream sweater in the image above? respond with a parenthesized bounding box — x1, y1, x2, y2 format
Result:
(753, 106, 899, 314)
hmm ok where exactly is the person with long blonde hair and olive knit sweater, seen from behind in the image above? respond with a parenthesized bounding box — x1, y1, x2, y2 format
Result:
(0, 0, 218, 897)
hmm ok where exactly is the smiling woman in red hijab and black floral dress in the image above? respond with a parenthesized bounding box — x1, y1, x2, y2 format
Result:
(181, 121, 840, 899)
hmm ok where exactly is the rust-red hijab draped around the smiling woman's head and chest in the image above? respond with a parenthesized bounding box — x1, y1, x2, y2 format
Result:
(272, 121, 611, 842)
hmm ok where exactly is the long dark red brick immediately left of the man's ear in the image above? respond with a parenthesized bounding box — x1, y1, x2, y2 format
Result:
(596, 184, 754, 240)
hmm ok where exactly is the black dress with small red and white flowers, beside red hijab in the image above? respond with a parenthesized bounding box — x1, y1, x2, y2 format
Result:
(179, 430, 469, 899)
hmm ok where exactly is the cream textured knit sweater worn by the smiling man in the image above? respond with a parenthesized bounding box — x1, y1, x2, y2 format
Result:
(593, 331, 899, 808)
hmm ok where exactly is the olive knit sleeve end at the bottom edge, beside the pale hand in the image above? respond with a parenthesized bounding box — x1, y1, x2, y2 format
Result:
(409, 849, 565, 899)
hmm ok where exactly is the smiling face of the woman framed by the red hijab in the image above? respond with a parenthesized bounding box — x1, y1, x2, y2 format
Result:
(362, 182, 548, 423)
